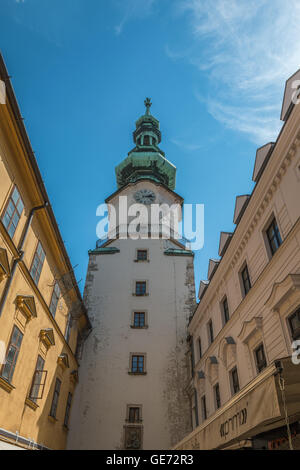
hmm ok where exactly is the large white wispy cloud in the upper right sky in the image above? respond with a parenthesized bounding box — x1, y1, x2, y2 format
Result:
(170, 0, 300, 144)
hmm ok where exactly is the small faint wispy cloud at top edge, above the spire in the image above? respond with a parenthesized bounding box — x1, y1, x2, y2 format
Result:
(114, 0, 157, 35)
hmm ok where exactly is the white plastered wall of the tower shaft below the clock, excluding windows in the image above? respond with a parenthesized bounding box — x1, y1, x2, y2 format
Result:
(68, 234, 195, 449)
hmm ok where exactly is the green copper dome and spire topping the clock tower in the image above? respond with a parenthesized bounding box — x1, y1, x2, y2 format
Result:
(115, 98, 176, 190)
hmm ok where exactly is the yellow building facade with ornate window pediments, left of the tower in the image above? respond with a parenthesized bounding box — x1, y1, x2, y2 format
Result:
(0, 56, 89, 449)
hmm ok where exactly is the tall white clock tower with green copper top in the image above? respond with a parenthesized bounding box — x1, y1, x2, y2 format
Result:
(68, 99, 195, 449)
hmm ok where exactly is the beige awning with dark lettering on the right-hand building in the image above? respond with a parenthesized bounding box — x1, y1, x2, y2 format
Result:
(175, 358, 300, 450)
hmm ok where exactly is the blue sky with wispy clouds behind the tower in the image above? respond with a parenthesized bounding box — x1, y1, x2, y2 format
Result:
(0, 0, 300, 290)
